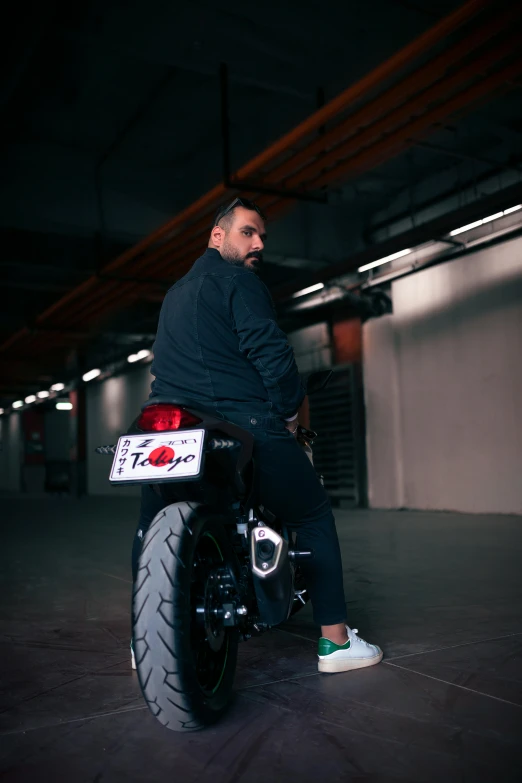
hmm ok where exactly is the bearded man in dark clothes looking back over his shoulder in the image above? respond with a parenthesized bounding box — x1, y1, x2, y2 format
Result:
(133, 198, 382, 672)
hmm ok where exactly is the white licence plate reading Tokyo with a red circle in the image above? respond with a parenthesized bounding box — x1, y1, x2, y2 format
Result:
(110, 430, 205, 484)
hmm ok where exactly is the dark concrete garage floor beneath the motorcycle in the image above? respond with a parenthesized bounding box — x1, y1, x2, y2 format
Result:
(0, 500, 522, 783)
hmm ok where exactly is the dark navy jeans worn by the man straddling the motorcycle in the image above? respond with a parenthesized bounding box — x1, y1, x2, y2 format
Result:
(132, 412, 346, 625)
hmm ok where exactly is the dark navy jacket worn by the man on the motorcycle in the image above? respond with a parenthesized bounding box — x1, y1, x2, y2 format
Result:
(148, 249, 305, 418)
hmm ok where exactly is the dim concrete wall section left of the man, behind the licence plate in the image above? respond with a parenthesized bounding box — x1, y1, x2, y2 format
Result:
(87, 364, 153, 495)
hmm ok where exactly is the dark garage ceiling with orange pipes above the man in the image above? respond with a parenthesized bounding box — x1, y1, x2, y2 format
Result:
(0, 0, 522, 407)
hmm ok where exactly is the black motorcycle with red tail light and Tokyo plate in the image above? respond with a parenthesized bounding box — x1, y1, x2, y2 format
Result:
(96, 371, 332, 731)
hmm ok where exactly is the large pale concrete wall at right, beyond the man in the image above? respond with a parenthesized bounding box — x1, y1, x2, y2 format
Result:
(363, 233, 522, 513)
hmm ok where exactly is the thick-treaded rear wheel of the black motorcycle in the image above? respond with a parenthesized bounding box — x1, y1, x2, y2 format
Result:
(133, 503, 239, 731)
